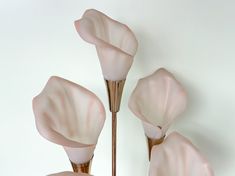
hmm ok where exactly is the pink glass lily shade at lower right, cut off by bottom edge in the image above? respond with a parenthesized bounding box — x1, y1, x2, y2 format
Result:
(149, 132, 213, 176)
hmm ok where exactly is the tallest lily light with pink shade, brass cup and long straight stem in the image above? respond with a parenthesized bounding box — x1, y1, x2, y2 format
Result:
(75, 9, 138, 176)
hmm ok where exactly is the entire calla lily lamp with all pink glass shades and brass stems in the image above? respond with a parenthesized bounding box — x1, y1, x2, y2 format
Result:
(33, 9, 213, 176)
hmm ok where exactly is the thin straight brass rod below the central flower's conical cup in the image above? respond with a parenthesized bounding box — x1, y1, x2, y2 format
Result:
(112, 112, 117, 176)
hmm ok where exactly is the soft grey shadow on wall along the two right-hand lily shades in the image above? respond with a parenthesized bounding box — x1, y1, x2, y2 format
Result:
(172, 79, 232, 174)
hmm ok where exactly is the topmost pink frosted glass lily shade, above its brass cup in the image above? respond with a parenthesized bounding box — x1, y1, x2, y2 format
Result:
(75, 9, 138, 81)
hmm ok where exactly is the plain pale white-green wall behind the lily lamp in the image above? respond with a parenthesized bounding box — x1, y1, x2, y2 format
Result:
(0, 0, 235, 176)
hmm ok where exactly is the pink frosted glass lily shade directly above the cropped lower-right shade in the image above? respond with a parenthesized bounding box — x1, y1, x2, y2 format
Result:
(129, 68, 187, 139)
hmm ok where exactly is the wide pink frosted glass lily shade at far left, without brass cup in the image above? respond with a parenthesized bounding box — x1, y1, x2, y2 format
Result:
(33, 76, 105, 164)
